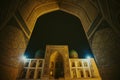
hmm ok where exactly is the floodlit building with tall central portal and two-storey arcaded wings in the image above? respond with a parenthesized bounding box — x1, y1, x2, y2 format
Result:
(19, 45, 101, 80)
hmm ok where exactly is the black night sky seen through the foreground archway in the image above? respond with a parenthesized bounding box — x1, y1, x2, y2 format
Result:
(25, 11, 91, 57)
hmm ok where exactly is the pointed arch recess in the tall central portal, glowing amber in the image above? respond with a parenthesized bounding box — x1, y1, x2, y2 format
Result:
(49, 51, 64, 79)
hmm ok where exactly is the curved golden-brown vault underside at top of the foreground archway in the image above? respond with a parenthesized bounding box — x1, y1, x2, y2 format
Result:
(19, 0, 98, 36)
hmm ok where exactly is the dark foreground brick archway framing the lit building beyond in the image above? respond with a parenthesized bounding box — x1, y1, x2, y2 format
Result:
(0, 0, 120, 80)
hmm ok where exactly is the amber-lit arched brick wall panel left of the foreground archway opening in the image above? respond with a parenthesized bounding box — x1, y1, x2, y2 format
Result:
(0, 26, 26, 80)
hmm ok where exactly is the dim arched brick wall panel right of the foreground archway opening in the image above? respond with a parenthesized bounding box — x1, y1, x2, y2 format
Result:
(92, 28, 120, 80)
